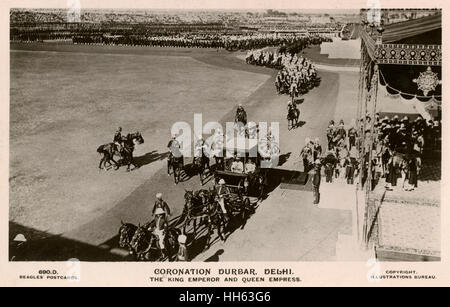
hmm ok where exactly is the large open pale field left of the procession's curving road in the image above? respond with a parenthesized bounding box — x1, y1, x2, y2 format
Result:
(10, 47, 269, 234)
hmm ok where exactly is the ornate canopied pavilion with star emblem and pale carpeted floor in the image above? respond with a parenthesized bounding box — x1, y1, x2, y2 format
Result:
(358, 9, 442, 261)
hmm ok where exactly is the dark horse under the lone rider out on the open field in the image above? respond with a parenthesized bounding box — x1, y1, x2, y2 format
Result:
(97, 132, 144, 171)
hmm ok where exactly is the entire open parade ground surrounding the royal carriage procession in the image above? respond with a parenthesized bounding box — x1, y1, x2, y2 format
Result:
(9, 44, 359, 261)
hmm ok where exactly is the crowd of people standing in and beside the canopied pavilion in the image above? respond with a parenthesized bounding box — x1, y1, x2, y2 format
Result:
(322, 113, 442, 191)
